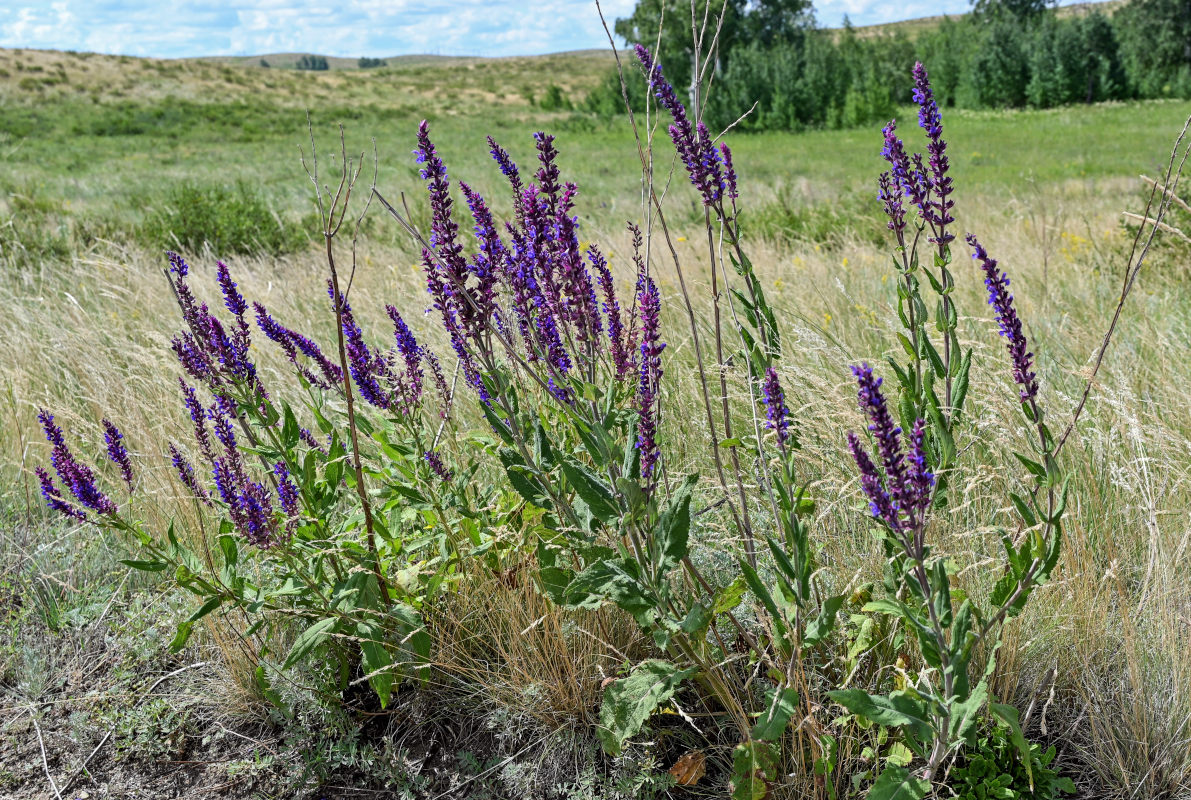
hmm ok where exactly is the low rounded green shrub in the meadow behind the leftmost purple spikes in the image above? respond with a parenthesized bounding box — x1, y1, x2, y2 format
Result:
(141, 182, 308, 255)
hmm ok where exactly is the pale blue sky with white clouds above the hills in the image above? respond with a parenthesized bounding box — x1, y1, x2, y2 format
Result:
(0, 0, 1086, 58)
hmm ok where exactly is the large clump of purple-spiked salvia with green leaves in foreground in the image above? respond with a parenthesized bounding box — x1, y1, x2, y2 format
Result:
(38, 45, 1119, 799)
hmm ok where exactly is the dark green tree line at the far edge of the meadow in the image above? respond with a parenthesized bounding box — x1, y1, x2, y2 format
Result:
(586, 0, 1191, 130)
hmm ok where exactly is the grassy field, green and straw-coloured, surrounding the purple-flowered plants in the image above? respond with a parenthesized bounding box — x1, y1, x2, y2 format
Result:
(0, 50, 1191, 799)
